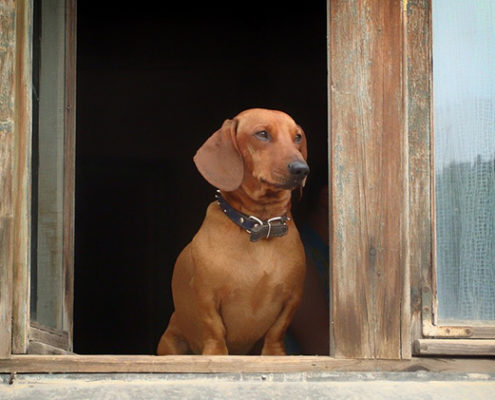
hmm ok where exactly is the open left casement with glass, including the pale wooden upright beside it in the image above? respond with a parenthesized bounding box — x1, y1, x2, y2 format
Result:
(2, 0, 75, 354)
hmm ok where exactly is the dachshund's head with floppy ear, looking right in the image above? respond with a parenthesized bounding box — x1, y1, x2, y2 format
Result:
(194, 108, 309, 192)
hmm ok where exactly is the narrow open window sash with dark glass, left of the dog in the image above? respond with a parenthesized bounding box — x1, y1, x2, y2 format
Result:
(27, 0, 75, 353)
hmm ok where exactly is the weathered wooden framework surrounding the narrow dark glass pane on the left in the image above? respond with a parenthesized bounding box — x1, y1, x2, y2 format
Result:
(0, 0, 76, 355)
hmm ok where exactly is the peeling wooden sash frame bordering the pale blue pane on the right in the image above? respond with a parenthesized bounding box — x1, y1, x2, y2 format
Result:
(407, 1, 495, 356)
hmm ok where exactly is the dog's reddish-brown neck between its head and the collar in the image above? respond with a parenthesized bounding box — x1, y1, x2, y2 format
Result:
(222, 185, 291, 220)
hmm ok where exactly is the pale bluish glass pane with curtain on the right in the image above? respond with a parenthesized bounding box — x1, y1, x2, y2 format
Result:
(433, 0, 495, 322)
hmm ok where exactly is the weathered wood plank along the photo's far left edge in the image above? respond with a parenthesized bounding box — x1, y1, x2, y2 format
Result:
(0, 0, 15, 357)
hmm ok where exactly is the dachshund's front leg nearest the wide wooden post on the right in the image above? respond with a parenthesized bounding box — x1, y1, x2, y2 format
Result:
(261, 297, 299, 356)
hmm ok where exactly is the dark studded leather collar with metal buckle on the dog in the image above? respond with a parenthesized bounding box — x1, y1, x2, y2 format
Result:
(215, 190, 290, 242)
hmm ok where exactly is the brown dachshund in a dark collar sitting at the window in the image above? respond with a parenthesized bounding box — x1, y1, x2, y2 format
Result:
(157, 109, 309, 355)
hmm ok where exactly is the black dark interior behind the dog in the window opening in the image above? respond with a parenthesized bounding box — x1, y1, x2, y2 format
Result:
(74, 1, 327, 354)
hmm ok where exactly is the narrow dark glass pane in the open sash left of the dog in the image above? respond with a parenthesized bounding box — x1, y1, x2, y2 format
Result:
(31, 0, 65, 329)
